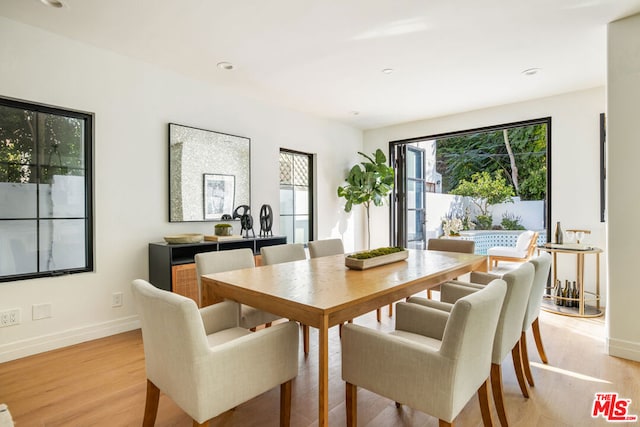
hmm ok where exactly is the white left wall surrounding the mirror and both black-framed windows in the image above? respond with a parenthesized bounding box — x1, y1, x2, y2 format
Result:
(0, 18, 362, 362)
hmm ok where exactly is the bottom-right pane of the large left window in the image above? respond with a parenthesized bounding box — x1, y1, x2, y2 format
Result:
(40, 219, 86, 271)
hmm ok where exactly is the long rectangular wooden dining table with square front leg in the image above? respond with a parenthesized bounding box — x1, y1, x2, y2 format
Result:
(202, 250, 487, 426)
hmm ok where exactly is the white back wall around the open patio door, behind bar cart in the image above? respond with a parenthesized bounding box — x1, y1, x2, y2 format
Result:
(364, 87, 607, 304)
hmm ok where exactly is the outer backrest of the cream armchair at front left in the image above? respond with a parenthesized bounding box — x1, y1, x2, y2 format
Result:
(131, 279, 214, 390)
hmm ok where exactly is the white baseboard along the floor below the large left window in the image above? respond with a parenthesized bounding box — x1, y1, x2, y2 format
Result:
(0, 315, 140, 363)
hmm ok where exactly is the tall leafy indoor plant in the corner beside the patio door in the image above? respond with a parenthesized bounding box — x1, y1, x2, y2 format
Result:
(338, 148, 394, 248)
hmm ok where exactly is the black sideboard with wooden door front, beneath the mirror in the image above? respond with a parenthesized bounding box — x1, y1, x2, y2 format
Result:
(149, 236, 287, 303)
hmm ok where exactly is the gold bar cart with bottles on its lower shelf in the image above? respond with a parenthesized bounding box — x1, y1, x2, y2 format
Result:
(538, 246, 603, 317)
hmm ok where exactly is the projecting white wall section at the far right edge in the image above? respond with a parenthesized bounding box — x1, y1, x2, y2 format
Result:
(607, 15, 640, 361)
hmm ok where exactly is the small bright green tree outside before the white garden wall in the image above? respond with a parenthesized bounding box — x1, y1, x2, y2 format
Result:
(451, 171, 515, 229)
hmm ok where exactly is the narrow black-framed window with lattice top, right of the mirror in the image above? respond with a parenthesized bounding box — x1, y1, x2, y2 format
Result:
(280, 149, 313, 244)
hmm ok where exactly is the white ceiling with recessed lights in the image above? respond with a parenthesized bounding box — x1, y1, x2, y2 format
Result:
(0, 0, 640, 129)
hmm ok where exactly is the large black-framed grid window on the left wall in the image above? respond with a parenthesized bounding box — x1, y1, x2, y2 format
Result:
(0, 98, 93, 282)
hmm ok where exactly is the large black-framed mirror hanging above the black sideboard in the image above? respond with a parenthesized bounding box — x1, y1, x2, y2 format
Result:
(169, 123, 251, 222)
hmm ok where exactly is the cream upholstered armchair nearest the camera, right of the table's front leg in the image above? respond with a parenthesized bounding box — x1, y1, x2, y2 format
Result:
(342, 279, 506, 427)
